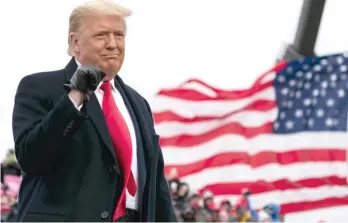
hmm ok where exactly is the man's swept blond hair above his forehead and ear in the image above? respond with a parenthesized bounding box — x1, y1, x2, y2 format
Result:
(68, 0, 132, 56)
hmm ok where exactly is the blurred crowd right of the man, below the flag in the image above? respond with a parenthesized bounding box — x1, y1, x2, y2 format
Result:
(167, 170, 283, 222)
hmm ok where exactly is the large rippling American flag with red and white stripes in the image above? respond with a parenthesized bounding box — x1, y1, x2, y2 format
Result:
(151, 51, 348, 214)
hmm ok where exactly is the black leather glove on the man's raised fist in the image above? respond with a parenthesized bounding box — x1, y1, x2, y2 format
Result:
(64, 65, 105, 101)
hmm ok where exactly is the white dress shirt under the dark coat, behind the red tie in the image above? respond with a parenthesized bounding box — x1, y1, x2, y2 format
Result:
(70, 61, 138, 210)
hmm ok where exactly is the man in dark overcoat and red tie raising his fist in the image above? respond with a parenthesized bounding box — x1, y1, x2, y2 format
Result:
(13, 0, 176, 222)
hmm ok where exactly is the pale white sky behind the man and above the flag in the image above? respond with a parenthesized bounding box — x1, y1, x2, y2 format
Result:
(0, 0, 348, 156)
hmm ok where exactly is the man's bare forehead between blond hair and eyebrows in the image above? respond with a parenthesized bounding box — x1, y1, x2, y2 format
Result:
(84, 15, 125, 32)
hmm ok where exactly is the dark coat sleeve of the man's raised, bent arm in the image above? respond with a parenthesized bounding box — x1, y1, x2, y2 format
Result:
(12, 75, 85, 174)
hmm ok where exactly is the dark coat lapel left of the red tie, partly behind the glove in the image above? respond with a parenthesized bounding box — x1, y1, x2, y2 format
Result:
(65, 57, 118, 164)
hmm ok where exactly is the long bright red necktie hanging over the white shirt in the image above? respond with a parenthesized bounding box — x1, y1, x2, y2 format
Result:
(100, 81, 137, 221)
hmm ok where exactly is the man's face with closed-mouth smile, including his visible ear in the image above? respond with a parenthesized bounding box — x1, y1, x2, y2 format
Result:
(70, 15, 125, 79)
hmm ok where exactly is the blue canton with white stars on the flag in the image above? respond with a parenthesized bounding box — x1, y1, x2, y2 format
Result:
(273, 54, 348, 133)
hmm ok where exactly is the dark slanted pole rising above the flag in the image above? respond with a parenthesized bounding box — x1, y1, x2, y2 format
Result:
(278, 0, 325, 61)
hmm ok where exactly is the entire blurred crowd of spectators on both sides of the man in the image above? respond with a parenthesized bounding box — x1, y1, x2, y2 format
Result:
(1, 149, 282, 222)
